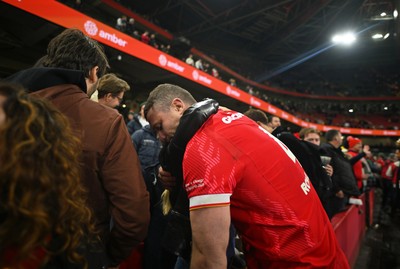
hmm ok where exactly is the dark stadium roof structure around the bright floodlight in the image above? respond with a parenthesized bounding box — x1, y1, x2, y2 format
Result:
(120, 0, 400, 92)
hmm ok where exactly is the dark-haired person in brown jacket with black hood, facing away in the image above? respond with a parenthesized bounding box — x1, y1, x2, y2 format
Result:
(9, 29, 150, 268)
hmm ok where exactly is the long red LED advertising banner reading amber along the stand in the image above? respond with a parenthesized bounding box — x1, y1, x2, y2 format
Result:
(3, 0, 400, 136)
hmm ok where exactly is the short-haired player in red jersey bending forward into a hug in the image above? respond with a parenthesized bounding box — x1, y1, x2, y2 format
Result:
(145, 84, 349, 269)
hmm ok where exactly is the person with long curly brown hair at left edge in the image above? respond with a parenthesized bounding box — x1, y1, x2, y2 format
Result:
(0, 83, 95, 268)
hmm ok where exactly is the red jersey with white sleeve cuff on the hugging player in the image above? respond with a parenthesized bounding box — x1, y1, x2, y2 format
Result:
(183, 110, 349, 269)
